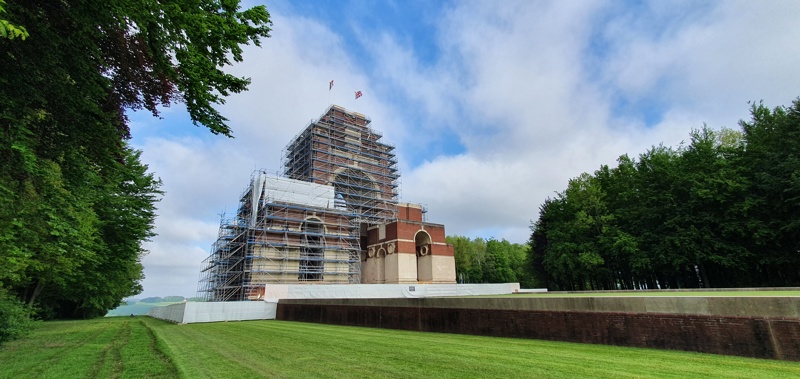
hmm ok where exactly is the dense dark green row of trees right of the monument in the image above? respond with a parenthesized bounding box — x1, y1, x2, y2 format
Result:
(527, 100, 800, 290)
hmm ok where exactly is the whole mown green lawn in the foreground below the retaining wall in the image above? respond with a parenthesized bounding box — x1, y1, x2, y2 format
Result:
(0, 317, 800, 378)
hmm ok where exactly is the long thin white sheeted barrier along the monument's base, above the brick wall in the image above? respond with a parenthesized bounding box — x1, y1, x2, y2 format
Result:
(264, 283, 519, 301)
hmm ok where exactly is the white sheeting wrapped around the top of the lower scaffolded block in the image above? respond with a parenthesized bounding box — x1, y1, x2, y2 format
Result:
(250, 172, 336, 224)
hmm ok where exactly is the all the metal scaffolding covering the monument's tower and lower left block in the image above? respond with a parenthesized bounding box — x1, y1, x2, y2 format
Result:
(198, 105, 400, 301)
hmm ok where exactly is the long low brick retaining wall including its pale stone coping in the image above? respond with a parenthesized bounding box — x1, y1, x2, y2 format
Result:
(277, 297, 800, 361)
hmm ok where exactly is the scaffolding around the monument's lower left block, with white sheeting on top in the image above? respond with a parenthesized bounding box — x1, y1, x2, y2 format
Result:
(198, 171, 361, 301)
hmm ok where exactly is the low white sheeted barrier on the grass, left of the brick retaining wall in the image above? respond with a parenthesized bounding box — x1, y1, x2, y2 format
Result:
(147, 301, 278, 324)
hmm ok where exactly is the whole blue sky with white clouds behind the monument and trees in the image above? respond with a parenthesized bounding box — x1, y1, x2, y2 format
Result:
(131, 0, 800, 296)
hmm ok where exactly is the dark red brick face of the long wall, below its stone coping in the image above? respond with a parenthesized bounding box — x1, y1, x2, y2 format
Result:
(277, 302, 800, 361)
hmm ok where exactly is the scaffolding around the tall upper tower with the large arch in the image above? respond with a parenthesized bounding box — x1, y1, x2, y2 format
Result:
(283, 105, 400, 224)
